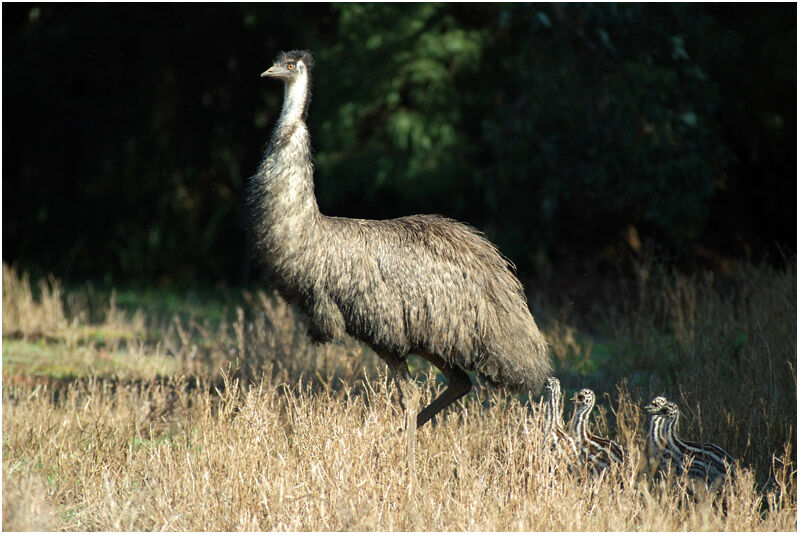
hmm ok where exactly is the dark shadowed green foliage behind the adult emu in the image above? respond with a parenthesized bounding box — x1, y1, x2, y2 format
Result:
(3, 4, 797, 284)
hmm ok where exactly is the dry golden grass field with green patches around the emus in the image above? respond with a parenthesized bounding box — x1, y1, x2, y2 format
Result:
(2, 262, 797, 531)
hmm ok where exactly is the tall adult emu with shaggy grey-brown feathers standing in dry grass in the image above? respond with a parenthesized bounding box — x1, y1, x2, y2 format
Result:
(247, 51, 550, 427)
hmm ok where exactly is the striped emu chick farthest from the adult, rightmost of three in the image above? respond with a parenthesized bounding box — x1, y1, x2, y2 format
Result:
(644, 396, 736, 482)
